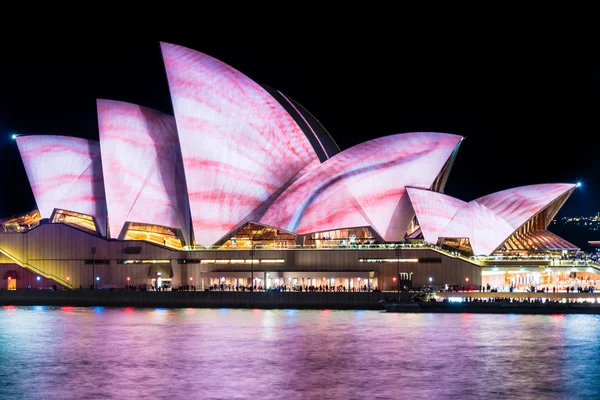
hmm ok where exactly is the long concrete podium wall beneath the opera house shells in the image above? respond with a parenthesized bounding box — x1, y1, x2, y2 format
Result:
(0, 224, 481, 291)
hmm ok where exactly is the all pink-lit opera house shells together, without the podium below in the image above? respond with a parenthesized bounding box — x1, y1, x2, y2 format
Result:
(3, 43, 576, 290)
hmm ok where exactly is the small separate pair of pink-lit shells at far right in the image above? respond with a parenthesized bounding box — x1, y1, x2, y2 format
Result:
(408, 183, 575, 256)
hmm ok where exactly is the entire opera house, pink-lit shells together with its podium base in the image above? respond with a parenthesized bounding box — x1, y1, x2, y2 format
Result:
(0, 43, 597, 290)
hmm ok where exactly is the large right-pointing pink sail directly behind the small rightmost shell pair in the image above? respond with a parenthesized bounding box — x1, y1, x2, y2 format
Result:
(341, 132, 462, 241)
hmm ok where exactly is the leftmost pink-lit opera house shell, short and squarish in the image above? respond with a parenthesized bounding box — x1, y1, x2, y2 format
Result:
(16, 135, 106, 235)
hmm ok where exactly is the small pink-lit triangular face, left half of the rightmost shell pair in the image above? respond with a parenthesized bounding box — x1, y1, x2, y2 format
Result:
(406, 187, 467, 244)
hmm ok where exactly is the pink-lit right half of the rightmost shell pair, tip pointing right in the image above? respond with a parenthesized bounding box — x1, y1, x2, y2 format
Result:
(475, 183, 575, 229)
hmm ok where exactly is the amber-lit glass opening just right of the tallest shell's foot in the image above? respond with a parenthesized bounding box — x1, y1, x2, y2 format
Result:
(221, 222, 296, 249)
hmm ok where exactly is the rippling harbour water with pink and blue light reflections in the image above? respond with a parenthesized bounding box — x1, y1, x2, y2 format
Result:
(0, 307, 600, 399)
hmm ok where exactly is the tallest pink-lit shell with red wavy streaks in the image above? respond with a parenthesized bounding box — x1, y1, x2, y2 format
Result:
(161, 43, 319, 246)
